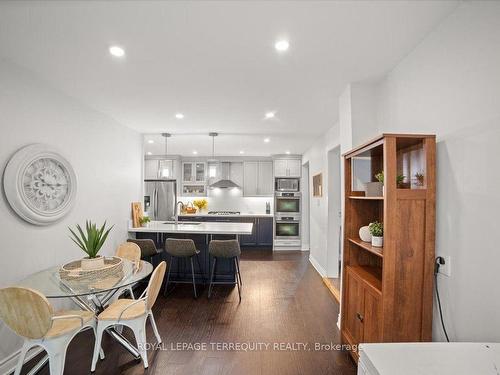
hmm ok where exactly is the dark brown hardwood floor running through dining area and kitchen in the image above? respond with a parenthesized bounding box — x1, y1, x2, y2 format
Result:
(25, 250, 356, 375)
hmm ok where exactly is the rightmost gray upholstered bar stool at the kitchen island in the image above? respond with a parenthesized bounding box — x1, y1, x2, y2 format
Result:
(208, 240, 243, 301)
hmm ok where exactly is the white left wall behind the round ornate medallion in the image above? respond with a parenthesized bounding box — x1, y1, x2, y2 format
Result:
(0, 60, 142, 373)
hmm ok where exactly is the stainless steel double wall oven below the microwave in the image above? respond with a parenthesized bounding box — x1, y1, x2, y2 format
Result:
(274, 191, 301, 248)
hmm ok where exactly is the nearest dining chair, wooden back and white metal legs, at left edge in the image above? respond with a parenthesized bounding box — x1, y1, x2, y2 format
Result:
(0, 287, 98, 375)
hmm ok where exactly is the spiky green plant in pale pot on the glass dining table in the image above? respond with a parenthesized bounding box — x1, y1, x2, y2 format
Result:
(68, 220, 113, 270)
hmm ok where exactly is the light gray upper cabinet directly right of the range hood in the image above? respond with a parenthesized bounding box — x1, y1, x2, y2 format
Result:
(243, 161, 273, 197)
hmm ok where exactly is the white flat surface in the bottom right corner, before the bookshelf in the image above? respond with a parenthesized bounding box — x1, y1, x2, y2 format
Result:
(360, 342, 500, 375)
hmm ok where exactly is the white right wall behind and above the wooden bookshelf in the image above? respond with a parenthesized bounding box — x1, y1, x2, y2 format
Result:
(378, 2, 500, 341)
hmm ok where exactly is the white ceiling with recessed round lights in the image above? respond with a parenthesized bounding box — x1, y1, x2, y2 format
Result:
(0, 1, 457, 155)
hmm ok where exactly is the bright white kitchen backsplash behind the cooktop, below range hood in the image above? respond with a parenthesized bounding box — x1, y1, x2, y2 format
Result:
(179, 189, 274, 214)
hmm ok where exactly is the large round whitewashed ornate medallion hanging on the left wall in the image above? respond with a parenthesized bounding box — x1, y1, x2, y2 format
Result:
(3, 143, 76, 225)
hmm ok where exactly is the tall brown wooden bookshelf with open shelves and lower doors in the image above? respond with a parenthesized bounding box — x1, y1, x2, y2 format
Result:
(341, 134, 436, 360)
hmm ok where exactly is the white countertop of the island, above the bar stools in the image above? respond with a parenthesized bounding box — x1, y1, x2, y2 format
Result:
(128, 221, 253, 235)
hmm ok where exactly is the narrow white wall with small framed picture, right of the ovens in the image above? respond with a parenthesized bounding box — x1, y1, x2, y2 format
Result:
(302, 123, 340, 276)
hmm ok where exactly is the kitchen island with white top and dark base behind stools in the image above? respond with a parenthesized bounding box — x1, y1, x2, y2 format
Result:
(128, 221, 253, 284)
